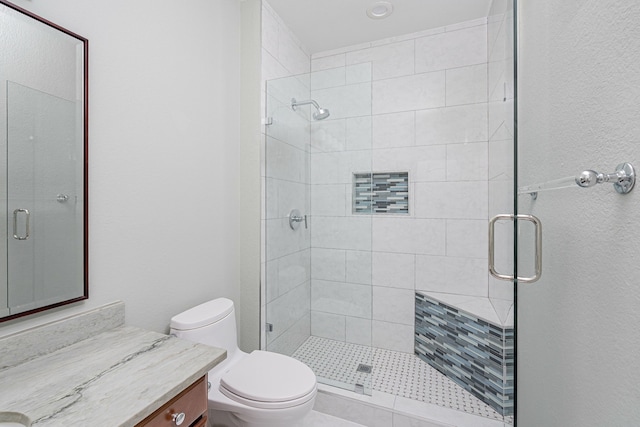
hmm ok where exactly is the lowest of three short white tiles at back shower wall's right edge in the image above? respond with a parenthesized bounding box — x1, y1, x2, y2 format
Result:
(447, 219, 488, 259)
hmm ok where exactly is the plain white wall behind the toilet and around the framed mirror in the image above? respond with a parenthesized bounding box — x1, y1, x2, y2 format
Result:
(0, 0, 241, 336)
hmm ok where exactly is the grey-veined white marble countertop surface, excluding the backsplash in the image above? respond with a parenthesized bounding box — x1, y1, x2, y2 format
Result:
(0, 326, 226, 427)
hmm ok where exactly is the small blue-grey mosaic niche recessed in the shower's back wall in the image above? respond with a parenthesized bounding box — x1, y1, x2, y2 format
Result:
(353, 172, 409, 215)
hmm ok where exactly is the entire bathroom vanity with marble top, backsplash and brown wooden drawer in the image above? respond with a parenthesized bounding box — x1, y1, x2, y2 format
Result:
(0, 302, 226, 427)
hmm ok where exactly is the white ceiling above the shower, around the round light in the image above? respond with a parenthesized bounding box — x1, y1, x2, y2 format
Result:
(267, 0, 491, 54)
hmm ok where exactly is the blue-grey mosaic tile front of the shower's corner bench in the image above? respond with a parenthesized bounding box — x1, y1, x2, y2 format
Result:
(415, 293, 514, 415)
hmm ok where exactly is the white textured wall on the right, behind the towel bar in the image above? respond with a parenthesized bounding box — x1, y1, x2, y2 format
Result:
(517, 0, 640, 427)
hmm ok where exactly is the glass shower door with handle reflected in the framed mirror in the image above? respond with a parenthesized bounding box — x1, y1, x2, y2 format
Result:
(6, 82, 83, 314)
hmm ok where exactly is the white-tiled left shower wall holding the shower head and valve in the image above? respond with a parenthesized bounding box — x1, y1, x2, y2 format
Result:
(261, 2, 311, 354)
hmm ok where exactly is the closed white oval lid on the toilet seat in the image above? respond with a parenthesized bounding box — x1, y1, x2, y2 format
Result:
(220, 350, 316, 406)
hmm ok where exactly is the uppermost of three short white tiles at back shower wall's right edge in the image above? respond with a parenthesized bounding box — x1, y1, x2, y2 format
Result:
(446, 64, 487, 106)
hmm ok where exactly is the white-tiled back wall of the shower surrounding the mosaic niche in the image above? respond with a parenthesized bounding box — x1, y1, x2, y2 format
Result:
(311, 19, 495, 353)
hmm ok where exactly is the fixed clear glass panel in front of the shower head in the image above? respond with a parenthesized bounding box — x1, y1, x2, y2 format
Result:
(263, 69, 374, 394)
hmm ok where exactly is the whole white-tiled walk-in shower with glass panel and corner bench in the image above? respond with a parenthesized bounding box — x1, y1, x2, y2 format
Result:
(263, 2, 515, 422)
